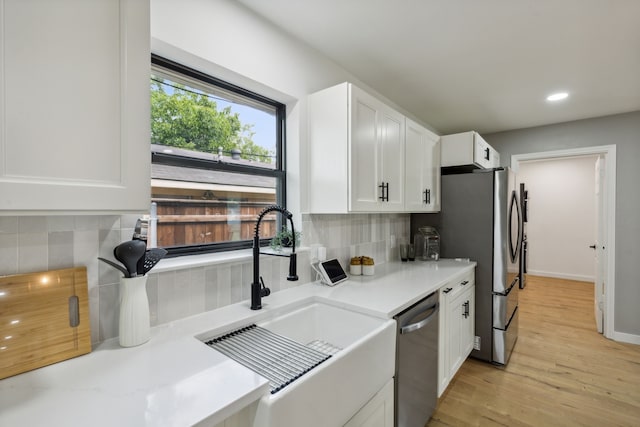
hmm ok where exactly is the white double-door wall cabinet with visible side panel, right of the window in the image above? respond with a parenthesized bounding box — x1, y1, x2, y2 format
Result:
(308, 83, 405, 213)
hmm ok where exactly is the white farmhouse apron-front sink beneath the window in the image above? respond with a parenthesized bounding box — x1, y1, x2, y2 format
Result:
(205, 302, 396, 427)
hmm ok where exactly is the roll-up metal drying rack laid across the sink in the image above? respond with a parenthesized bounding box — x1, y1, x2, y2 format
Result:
(205, 324, 341, 394)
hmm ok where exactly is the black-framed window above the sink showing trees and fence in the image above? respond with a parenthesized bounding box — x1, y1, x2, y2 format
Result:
(150, 55, 286, 255)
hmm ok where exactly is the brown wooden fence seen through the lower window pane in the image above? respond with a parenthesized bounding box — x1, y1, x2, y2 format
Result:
(153, 199, 277, 247)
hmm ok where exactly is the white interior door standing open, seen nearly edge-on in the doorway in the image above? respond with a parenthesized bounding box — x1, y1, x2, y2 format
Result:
(594, 156, 607, 333)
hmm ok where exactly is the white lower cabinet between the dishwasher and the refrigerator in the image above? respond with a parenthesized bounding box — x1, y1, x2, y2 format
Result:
(438, 271, 475, 397)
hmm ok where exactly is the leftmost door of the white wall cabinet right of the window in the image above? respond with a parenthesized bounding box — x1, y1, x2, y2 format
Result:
(349, 86, 382, 212)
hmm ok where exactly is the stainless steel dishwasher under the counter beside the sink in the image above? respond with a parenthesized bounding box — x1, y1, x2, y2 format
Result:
(394, 292, 439, 427)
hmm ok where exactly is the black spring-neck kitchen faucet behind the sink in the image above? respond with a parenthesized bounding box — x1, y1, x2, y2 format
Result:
(251, 205, 298, 310)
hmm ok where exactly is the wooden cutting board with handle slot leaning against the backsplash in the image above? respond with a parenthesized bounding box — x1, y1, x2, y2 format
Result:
(0, 267, 91, 379)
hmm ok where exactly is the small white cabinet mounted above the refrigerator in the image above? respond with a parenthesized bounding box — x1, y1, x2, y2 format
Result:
(441, 131, 500, 169)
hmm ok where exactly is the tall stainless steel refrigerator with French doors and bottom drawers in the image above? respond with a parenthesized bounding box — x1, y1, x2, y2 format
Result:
(411, 168, 522, 365)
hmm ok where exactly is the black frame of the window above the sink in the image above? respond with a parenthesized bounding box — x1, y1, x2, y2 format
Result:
(149, 53, 287, 257)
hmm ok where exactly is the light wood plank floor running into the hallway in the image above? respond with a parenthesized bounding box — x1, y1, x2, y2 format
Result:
(427, 276, 640, 427)
